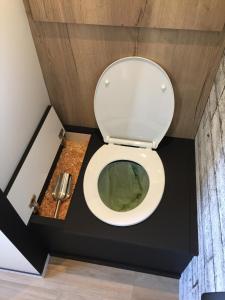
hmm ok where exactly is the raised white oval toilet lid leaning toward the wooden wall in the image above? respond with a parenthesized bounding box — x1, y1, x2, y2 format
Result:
(94, 57, 174, 148)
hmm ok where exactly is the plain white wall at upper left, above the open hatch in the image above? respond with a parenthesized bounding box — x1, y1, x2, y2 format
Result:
(0, 0, 49, 191)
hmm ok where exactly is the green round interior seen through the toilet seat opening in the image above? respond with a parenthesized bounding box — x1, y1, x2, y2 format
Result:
(98, 161, 149, 212)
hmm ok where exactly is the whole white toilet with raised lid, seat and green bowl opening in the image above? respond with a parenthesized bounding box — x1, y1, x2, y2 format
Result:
(83, 57, 174, 226)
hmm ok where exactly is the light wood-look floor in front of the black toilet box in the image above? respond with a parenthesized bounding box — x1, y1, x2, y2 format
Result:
(0, 257, 178, 300)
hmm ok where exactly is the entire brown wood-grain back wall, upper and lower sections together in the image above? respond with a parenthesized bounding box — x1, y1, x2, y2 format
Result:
(24, 0, 225, 138)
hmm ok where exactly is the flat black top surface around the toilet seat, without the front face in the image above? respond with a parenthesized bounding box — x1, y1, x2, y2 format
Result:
(64, 131, 197, 254)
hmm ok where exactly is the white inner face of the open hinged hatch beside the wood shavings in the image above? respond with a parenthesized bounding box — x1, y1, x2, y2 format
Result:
(7, 108, 63, 224)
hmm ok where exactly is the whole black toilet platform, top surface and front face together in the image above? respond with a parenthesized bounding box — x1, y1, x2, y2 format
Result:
(29, 128, 198, 277)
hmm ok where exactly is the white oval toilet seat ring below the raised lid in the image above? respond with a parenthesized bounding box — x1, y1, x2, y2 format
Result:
(83, 144, 165, 226)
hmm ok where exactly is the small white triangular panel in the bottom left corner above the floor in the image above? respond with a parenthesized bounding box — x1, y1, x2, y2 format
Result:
(0, 231, 39, 275)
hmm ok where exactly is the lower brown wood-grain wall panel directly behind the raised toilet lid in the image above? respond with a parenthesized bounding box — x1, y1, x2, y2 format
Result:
(24, 0, 225, 138)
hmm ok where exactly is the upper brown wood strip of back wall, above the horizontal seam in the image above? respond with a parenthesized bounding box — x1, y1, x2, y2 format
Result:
(29, 0, 225, 31)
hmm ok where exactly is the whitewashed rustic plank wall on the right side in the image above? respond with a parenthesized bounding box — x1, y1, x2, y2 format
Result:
(180, 53, 225, 300)
